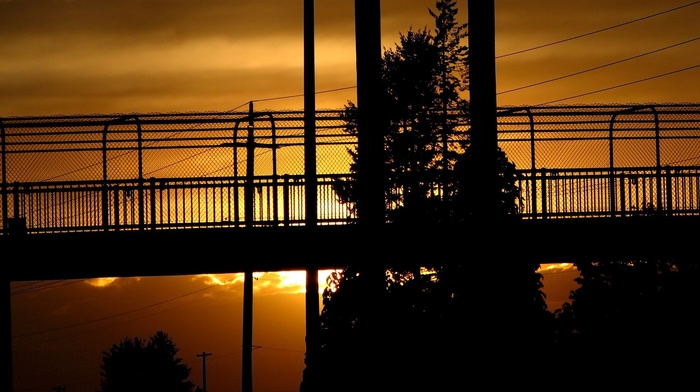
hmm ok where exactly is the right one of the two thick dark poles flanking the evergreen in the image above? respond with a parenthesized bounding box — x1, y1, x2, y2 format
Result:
(464, 0, 498, 385)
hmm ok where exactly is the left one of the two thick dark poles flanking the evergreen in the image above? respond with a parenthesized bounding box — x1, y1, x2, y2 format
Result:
(355, 0, 388, 390)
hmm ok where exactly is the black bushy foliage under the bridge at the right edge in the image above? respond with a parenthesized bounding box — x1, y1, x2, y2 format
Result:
(556, 259, 700, 389)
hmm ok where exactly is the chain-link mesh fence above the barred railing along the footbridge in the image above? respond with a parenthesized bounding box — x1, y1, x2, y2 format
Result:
(0, 104, 700, 183)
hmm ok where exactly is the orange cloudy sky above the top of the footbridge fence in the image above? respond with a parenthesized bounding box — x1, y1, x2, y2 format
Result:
(0, 0, 700, 117)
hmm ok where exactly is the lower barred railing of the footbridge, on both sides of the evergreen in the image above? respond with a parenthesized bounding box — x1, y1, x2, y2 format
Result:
(7, 167, 700, 233)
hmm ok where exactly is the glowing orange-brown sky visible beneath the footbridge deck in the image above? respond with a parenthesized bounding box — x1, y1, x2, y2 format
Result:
(11, 265, 576, 392)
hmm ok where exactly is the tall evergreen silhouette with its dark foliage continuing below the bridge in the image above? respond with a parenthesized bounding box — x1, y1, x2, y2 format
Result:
(301, 0, 552, 392)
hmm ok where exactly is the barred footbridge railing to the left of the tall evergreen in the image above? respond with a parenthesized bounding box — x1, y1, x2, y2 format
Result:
(7, 175, 354, 233)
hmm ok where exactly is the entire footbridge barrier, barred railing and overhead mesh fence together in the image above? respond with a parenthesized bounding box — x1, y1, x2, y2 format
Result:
(0, 104, 700, 235)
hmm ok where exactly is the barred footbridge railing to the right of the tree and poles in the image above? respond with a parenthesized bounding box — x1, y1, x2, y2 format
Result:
(519, 167, 700, 219)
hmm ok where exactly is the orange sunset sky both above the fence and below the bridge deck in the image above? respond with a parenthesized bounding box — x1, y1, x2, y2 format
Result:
(6, 0, 700, 392)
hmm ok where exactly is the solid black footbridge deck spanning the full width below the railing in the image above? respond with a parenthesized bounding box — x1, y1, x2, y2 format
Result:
(0, 216, 700, 281)
